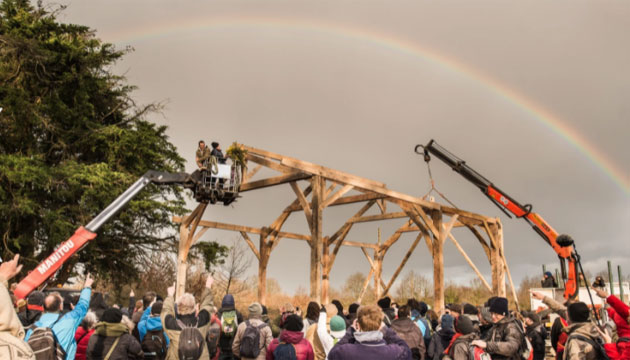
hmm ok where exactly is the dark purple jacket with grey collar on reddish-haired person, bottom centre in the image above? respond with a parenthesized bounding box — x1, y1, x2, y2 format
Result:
(328, 327, 411, 360)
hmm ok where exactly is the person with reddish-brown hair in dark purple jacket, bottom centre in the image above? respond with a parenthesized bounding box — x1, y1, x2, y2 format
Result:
(328, 305, 411, 360)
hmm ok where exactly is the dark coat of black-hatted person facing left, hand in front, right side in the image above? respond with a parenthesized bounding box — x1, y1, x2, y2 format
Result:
(486, 317, 523, 360)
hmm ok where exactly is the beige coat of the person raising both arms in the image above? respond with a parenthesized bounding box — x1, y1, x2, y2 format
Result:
(160, 288, 212, 360)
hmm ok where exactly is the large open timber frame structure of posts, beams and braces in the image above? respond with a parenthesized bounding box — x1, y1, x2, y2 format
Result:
(173, 145, 516, 310)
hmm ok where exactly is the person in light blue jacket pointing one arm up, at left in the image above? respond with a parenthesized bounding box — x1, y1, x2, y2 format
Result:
(24, 273, 94, 360)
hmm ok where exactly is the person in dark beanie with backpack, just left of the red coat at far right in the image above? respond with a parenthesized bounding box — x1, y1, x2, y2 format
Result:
(562, 302, 605, 360)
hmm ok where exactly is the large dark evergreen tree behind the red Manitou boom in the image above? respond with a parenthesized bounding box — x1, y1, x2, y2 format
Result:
(0, 0, 225, 282)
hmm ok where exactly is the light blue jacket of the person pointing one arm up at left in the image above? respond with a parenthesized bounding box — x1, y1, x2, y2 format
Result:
(24, 288, 92, 360)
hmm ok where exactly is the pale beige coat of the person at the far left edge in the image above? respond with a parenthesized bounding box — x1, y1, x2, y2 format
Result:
(0, 276, 35, 360)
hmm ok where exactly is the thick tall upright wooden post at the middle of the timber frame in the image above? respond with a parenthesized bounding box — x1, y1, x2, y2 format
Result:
(310, 176, 325, 302)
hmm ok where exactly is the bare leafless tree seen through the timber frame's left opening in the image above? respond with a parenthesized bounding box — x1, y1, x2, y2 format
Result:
(217, 238, 252, 295)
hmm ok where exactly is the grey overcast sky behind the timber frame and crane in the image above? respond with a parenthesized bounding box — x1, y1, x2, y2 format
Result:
(56, 0, 630, 292)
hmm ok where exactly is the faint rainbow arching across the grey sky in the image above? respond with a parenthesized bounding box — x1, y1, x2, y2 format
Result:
(107, 16, 630, 195)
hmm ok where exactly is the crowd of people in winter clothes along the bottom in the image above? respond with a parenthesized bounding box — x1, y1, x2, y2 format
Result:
(0, 256, 630, 360)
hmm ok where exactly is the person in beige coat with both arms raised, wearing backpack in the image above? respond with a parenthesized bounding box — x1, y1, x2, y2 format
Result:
(160, 275, 216, 360)
